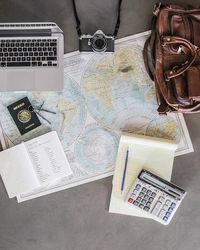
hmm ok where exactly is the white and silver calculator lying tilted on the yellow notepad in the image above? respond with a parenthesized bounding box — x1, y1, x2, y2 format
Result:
(126, 169, 186, 225)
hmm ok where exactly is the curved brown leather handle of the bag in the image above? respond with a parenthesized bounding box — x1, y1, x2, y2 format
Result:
(162, 36, 199, 81)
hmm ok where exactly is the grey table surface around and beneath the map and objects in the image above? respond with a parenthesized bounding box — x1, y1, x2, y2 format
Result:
(0, 0, 200, 250)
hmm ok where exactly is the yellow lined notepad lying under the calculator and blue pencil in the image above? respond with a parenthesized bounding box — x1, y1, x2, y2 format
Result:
(109, 133, 177, 217)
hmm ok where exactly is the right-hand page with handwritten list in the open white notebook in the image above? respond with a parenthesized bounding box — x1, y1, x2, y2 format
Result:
(25, 131, 72, 185)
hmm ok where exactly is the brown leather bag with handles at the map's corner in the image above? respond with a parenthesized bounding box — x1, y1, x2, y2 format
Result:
(144, 4, 200, 114)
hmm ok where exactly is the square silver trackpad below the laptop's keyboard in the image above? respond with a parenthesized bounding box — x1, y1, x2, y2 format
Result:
(6, 69, 35, 91)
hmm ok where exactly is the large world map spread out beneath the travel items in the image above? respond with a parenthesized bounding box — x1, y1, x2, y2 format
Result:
(0, 32, 193, 202)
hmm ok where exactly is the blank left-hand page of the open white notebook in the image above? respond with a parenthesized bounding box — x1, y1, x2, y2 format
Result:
(0, 143, 40, 198)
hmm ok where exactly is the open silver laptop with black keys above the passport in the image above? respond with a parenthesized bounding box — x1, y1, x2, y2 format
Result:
(0, 22, 64, 91)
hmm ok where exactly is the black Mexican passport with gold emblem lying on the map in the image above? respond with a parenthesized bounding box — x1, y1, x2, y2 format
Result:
(7, 97, 41, 135)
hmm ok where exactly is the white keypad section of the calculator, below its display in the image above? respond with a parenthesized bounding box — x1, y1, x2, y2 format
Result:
(127, 179, 182, 224)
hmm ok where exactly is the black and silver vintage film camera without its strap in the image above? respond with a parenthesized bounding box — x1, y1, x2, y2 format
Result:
(79, 30, 115, 52)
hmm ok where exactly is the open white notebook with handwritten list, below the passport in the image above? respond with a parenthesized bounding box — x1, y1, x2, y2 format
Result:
(0, 131, 72, 198)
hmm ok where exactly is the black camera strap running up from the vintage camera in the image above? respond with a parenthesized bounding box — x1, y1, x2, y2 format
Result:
(72, 0, 122, 37)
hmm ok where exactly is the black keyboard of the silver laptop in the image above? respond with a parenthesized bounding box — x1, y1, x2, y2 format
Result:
(0, 38, 58, 67)
